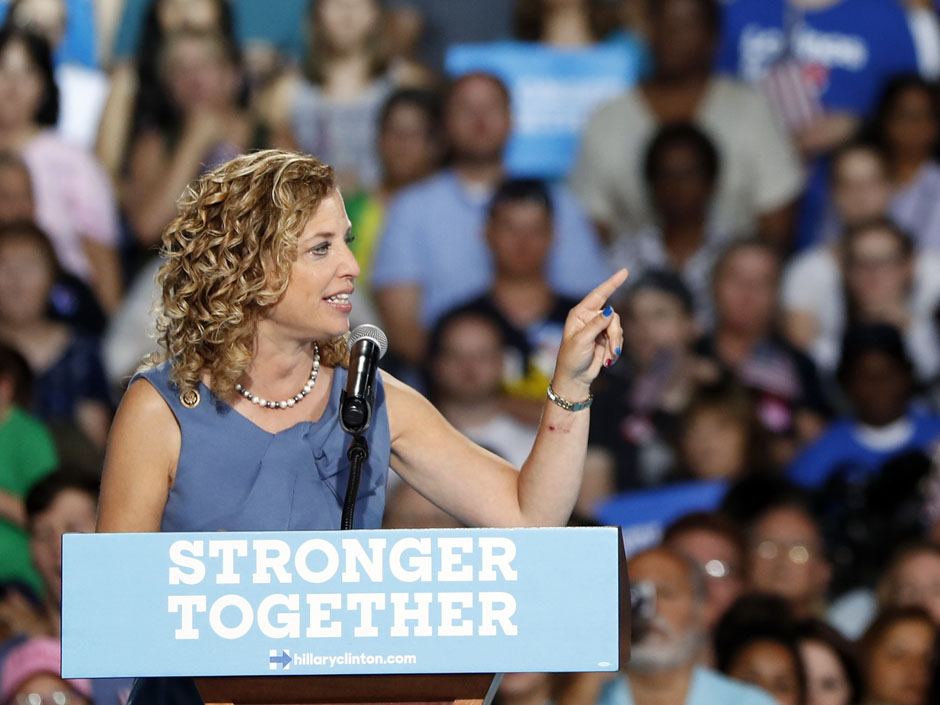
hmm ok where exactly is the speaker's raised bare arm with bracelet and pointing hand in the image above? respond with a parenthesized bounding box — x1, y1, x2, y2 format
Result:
(384, 270, 627, 526)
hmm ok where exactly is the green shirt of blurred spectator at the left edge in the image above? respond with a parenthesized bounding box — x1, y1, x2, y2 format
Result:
(0, 406, 57, 594)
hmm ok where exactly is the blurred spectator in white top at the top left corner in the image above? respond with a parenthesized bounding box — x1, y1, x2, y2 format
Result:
(4, 0, 108, 150)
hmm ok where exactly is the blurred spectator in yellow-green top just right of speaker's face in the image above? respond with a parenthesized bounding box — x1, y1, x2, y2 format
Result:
(344, 88, 444, 310)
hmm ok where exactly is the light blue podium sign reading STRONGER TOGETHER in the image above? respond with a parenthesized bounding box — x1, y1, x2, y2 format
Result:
(62, 527, 620, 678)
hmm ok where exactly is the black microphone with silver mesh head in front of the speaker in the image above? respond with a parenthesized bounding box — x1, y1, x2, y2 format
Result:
(339, 323, 388, 436)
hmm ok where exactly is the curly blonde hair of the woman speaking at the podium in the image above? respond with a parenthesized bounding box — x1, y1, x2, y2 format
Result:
(149, 149, 347, 399)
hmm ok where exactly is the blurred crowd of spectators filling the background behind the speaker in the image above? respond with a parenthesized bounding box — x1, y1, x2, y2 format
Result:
(0, 0, 940, 705)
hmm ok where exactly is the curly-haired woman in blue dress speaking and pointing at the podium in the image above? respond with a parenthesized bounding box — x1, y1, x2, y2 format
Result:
(98, 150, 627, 532)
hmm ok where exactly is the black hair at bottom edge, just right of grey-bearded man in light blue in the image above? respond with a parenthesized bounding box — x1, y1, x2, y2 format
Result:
(713, 593, 806, 703)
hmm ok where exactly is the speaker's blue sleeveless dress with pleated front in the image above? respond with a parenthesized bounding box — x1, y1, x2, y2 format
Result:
(128, 362, 391, 705)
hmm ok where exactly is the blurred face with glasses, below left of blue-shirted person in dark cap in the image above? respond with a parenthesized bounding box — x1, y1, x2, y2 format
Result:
(747, 498, 832, 618)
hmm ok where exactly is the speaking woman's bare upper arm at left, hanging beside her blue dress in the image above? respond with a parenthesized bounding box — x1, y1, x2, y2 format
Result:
(97, 379, 181, 533)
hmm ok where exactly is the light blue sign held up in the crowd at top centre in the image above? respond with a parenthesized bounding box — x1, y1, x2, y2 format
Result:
(446, 42, 639, 179)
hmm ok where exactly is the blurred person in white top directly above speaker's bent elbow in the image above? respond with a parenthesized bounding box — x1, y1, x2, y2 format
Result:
(426, 311, 537, 468)
